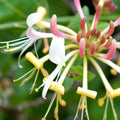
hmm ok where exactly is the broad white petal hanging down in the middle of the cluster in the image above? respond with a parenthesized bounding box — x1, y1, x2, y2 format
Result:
(49, 37, 65, 65)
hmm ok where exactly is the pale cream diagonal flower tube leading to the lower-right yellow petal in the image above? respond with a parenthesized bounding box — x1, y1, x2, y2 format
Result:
(89, 56, 113, 92)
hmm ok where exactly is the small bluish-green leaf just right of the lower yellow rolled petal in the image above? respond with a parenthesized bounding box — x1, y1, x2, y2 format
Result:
(63, 77, 74, 91)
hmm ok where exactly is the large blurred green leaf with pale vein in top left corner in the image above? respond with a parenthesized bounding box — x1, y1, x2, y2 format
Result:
(0, 0, 38, 23)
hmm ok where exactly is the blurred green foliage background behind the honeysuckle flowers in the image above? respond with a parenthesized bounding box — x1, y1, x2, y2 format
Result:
(0, 0, 120, 120)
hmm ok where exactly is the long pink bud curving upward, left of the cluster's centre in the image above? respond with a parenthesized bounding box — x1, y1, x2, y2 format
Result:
(50, 15, 76, 43)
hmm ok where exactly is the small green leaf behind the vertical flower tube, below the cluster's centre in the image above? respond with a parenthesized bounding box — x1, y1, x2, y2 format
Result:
(71, 66, 95, 81)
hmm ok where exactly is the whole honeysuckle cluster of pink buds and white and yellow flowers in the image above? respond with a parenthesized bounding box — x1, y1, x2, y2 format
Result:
(0, 0, 120, 120)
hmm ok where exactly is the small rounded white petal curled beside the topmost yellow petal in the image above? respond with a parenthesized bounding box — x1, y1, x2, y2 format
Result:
(26, 13, 40, 27)
